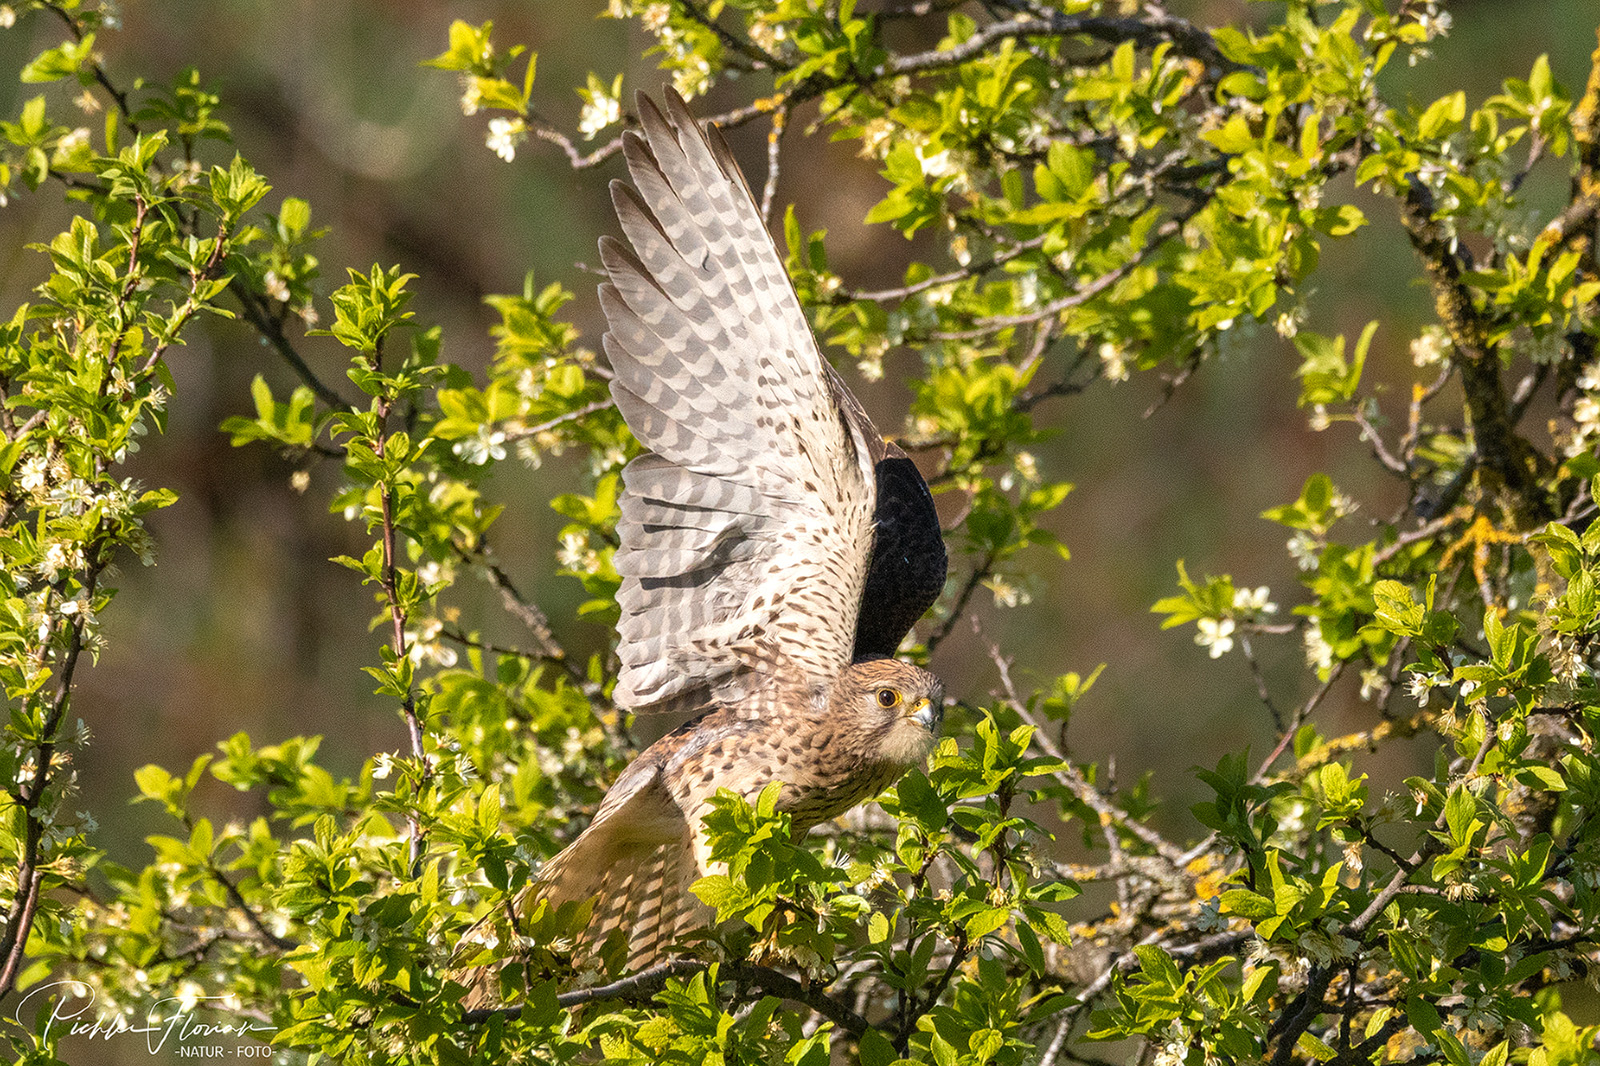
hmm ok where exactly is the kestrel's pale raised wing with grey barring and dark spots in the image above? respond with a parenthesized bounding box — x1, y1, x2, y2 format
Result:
(600, 94, 876, 709)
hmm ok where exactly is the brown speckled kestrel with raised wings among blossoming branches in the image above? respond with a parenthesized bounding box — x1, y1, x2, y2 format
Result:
(478, 93, 946, 996)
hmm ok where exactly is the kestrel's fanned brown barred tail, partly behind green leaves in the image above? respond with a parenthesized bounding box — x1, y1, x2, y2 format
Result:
(459, 813, 714, 1010)
